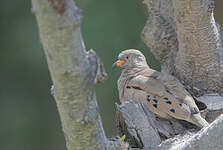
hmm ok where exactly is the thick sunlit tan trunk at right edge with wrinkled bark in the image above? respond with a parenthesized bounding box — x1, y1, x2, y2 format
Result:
(172, 0, 223, 95)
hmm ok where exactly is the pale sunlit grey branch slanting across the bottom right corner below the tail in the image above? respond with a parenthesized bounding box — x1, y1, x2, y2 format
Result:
(159, 115, 223, 150)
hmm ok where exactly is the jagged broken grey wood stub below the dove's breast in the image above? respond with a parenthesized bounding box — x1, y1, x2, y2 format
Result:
(116, 101, 161, 148)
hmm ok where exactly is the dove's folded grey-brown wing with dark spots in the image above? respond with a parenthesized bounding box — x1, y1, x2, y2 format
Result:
(129, 72, 199, 120)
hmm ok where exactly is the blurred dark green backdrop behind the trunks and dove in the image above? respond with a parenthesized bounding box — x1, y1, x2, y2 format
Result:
(0, 0, 223, 150)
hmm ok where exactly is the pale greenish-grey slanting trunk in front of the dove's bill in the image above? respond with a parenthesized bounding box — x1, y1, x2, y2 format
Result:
(32, 0, 126, 150)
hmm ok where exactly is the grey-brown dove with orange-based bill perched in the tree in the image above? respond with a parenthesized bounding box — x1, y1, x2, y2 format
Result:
(112, 49, 209, 128)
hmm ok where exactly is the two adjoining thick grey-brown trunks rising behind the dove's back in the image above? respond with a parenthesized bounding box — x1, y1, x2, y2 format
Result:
(142, 0, 223, 96)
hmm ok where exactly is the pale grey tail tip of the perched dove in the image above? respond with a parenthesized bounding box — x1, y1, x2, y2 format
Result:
(190, 113, 209, 128)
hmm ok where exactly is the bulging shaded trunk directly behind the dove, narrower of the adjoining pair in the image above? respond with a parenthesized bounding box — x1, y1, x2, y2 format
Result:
(142, 0, 178, 75)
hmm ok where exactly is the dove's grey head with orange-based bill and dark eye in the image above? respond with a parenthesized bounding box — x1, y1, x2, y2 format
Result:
(112, 49, 147, 69)
